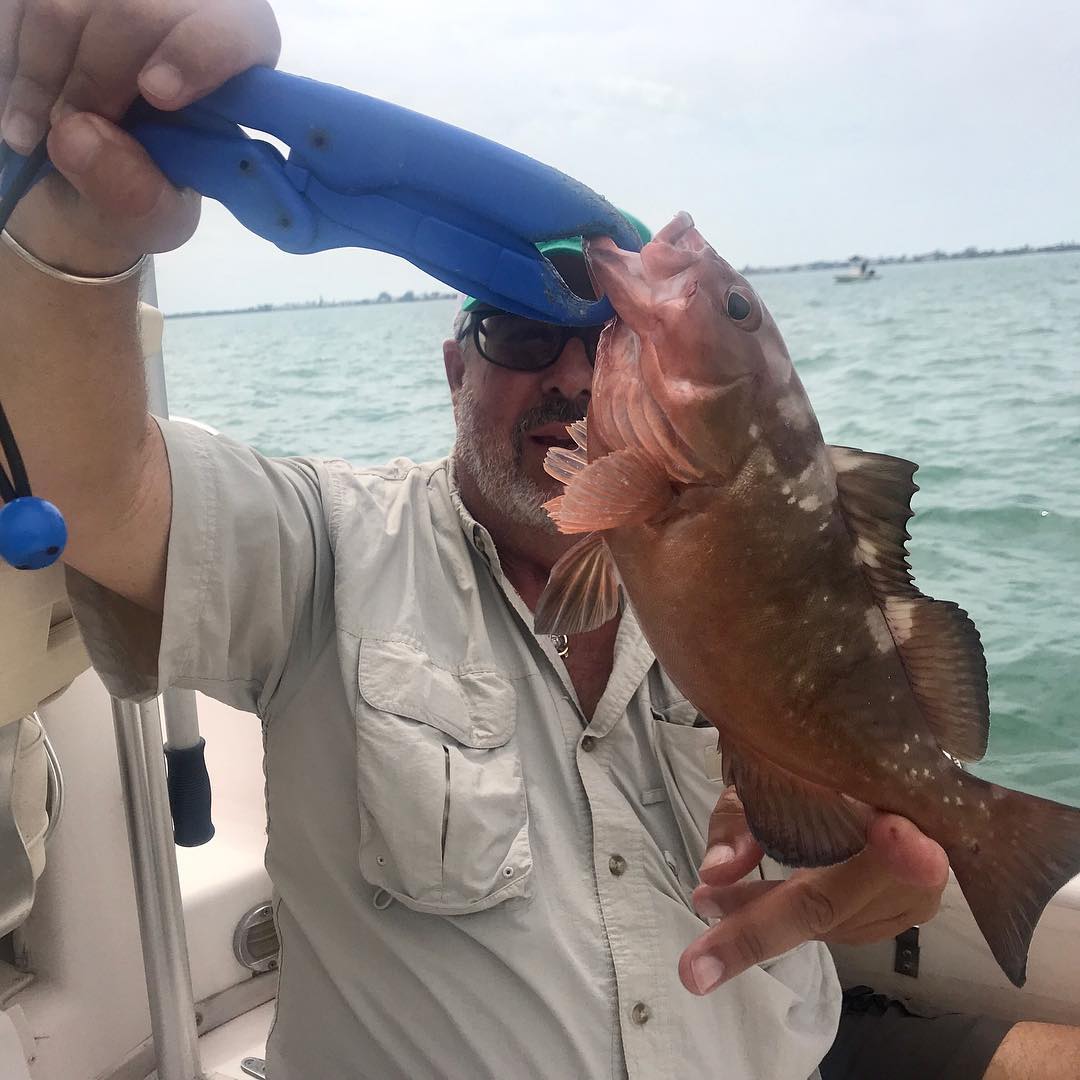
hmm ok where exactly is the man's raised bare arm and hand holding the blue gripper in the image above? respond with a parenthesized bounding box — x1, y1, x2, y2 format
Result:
(0, 0, 280, 610)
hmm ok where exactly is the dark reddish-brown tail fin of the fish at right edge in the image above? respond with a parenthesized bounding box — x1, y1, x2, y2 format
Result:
(945, 774, 1080, 986)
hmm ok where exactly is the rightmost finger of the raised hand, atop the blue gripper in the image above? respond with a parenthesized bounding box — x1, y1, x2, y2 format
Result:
(138, 0, 281, 109)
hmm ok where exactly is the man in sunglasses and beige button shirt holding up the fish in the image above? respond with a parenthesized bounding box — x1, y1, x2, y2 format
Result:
(0, 0, 1066, 1080)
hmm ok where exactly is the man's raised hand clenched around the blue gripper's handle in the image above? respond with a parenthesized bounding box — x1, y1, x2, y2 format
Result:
(0, 0, 281, 274)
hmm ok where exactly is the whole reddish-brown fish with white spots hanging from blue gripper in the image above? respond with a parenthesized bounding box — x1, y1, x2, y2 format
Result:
(535, 213, 1080, 986)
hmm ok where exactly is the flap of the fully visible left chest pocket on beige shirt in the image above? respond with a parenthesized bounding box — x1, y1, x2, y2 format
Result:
(360, 637, 516, 750)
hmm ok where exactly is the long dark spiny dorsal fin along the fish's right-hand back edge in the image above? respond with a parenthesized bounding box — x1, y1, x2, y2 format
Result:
(828, 446, 990, 761)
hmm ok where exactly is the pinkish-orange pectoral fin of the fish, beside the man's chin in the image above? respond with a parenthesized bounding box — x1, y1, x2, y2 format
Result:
(544, 450, 674, 532)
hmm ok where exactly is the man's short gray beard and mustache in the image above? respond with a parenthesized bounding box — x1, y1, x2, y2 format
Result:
(454, 379, 580, 535)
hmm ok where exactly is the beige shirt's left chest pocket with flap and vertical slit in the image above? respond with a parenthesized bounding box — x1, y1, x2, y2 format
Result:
(356, 639, 532, 915)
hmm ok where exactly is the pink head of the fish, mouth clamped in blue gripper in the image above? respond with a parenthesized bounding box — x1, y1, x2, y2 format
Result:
(585, 213, 794, 472)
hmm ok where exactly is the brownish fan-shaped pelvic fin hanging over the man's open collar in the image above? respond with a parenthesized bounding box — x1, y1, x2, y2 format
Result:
(532, 532, 619, 634)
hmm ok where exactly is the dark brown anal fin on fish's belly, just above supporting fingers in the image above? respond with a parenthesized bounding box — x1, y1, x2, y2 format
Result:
(724, 745, 868, 866)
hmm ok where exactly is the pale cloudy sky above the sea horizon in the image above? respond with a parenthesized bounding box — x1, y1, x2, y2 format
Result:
(157, 0, 1080, 312)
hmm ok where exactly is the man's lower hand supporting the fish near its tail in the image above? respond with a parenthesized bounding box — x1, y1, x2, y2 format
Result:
(679, 788, 948, 994)
